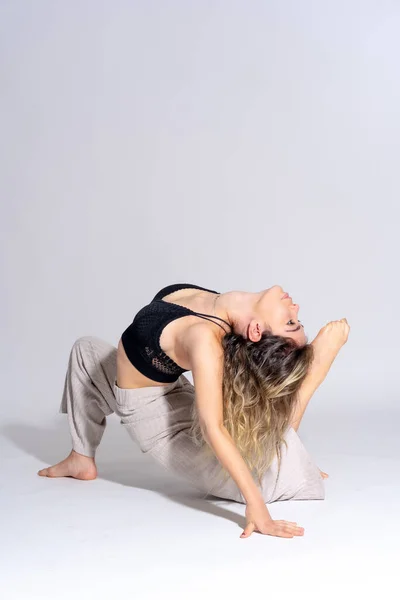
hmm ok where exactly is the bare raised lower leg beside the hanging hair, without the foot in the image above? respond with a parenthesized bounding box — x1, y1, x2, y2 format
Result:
(291, 347, 337, 431)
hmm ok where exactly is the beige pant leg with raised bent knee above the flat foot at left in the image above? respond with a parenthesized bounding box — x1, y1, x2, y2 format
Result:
(59, 336, 117, 457)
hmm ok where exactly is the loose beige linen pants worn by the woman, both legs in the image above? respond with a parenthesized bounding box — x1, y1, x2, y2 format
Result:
(59, 336, 325, 504)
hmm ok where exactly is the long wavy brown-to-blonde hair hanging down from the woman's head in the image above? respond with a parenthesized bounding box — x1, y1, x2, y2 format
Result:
(189, 330, 314, 496)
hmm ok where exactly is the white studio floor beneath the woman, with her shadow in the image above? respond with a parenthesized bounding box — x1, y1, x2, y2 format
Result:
(0, 406, 400, 600)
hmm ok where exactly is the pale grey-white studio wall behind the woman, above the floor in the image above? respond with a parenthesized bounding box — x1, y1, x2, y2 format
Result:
(0, 0, 400, 427)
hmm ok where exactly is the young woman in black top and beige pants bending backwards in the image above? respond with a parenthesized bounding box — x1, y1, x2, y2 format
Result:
(38, 283, 349, 537)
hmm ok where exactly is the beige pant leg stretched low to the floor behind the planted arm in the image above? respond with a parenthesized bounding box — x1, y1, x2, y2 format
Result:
(115, 375, 325, 504)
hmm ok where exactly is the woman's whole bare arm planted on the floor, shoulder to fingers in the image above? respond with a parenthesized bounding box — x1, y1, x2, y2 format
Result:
(186, 326, 304, 537)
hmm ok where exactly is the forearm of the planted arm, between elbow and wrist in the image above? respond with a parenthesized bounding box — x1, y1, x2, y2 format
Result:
(204, 425, 266, 508)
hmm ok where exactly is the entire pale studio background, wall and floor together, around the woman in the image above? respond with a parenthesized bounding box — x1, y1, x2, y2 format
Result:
(0, 0, 400, 600)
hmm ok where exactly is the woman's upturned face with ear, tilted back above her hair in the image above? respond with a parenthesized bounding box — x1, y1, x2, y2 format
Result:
(248, 285, 308, 346)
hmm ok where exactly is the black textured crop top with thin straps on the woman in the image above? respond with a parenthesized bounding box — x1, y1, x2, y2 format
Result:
(121, 283, 231, 383)
